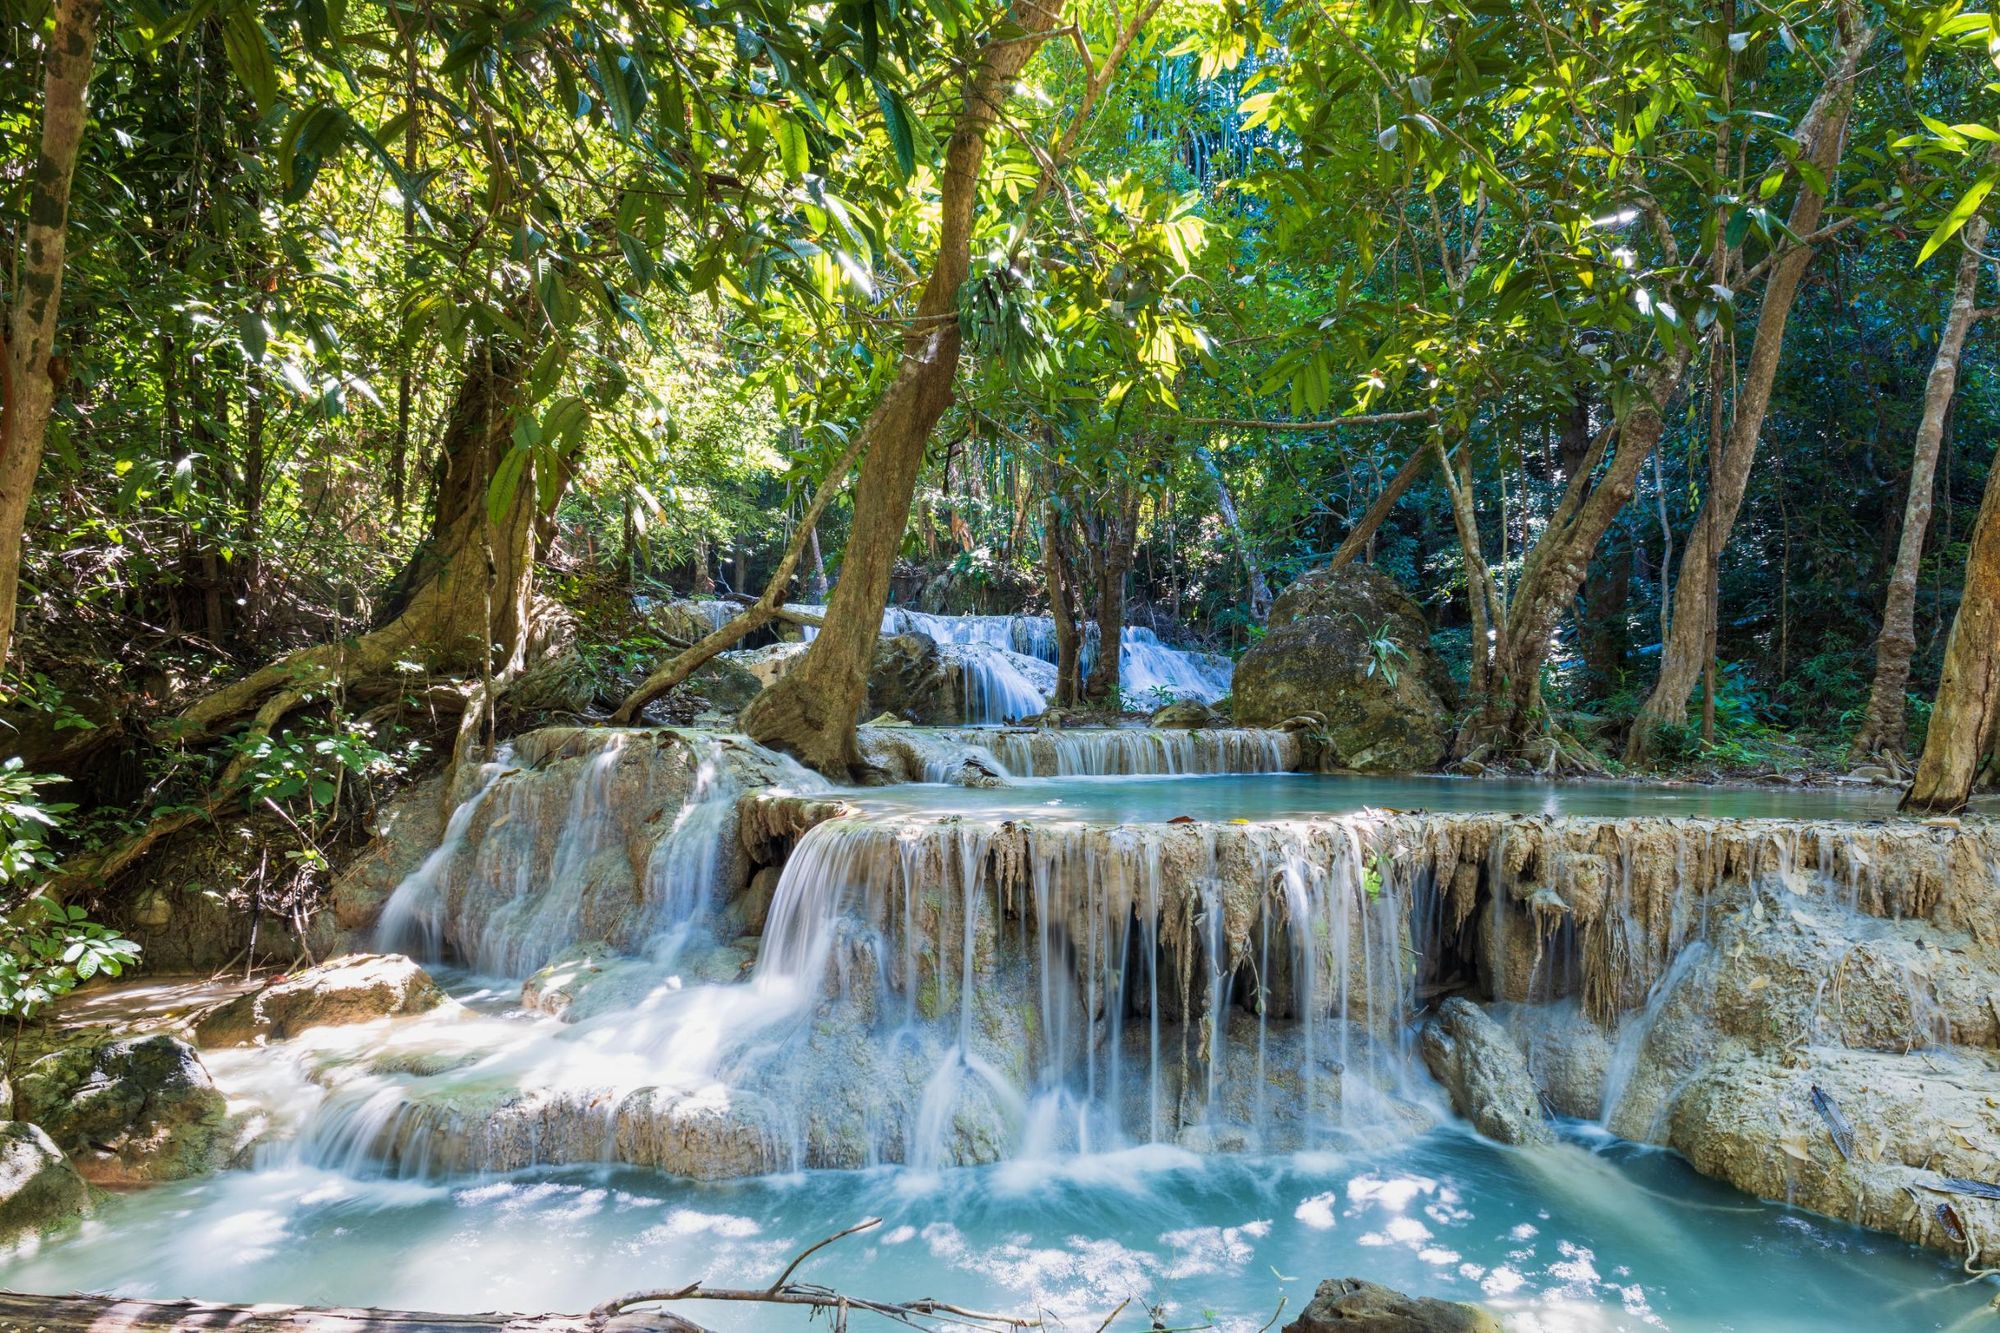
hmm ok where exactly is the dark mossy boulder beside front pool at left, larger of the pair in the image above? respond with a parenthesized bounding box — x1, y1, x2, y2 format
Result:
(18, 1033, 230, 1185)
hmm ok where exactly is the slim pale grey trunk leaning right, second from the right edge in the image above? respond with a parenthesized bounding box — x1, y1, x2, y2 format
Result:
(1852, 201, 1988, 763)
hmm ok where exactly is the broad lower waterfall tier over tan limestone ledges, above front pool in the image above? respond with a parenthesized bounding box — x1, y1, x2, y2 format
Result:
(300, 729, 2000, 1257)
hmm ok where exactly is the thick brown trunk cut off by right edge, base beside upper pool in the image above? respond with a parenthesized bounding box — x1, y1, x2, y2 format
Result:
(1902, 456, 2000, 813)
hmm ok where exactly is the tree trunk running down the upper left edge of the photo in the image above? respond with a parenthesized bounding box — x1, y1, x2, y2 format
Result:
(0, 0, 100, 669)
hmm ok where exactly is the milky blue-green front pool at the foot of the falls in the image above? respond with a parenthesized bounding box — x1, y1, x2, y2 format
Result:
(0, 1129, 1994, 1333)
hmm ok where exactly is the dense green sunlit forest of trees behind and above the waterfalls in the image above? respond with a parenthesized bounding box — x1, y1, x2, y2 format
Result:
(0, 0, 2000, 980)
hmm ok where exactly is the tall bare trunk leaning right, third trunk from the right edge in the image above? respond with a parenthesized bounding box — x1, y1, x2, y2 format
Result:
(1626, 28, 1874, 763)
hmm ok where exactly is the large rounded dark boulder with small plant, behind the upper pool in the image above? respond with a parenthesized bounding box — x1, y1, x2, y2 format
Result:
(1230, 564, 1452, 773)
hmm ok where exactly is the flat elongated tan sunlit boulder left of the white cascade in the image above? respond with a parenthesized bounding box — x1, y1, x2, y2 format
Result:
(194, 953, 444, 1047)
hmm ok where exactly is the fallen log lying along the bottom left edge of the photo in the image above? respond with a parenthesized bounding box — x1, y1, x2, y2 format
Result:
(0, 1291, 706, 1333)
